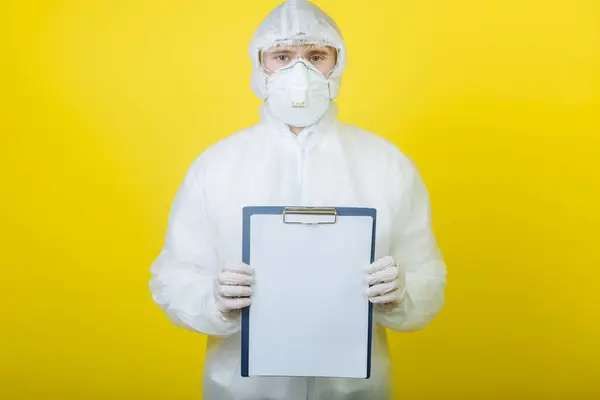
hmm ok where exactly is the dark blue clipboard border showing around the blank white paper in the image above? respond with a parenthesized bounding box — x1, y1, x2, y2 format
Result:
(240, 206, 377, 379)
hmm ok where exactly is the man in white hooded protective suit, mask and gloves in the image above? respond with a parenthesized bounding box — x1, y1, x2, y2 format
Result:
(150, 0, 446, 400)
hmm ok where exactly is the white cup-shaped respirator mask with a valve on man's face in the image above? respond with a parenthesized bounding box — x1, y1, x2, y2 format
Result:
(266, 58, 330, 127)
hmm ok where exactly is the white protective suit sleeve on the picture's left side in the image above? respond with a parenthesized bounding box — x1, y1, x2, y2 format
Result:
(150, 161, 240, 337)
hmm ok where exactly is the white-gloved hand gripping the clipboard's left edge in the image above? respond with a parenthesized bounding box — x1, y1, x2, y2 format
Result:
(214, 263, 254, 317)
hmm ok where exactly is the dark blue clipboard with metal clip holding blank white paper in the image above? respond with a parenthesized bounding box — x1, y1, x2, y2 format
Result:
(240, 206, 377, 379)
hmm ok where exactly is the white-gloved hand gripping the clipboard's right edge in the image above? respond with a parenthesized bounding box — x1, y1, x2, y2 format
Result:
(367, 256, 406, 311)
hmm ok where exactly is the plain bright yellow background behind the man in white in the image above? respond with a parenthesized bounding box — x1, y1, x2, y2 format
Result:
(0, 0, 600, 400)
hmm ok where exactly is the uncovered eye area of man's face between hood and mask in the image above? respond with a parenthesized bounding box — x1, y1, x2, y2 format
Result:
(261, 44, 337, 77)
